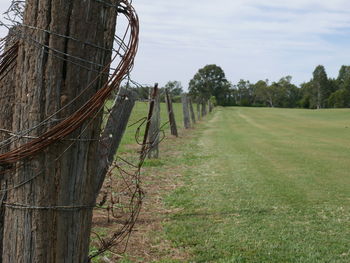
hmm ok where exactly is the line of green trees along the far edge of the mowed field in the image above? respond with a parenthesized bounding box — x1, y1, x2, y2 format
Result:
(189, 64, 350, 109)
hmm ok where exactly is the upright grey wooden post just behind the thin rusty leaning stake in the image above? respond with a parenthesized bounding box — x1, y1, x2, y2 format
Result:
(148, 84, 160, 159)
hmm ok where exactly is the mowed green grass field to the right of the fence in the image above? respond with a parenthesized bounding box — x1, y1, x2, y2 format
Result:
(166, 108, 350, 262)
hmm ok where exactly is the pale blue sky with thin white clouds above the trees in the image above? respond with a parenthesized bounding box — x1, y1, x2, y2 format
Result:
(0, 0, 350, 89)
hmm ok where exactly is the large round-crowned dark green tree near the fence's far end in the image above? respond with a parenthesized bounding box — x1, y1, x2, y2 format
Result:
(189, 64, 231, 105)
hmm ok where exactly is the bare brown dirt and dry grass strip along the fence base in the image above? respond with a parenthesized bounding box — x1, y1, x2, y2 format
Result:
(92, 137, 189, 262)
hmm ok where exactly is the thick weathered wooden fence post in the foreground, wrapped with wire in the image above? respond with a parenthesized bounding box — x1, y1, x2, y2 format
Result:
(3, 0, 120, 263)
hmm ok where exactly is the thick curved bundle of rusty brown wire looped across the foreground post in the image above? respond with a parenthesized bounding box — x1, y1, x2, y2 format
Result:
(0, 0, 139, 166)
